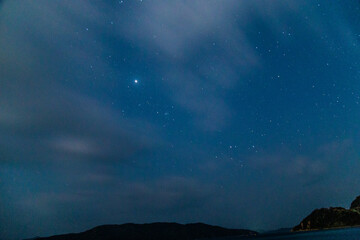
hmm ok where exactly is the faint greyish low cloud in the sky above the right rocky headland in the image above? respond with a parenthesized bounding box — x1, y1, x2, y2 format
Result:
(248, 139, 354, 184)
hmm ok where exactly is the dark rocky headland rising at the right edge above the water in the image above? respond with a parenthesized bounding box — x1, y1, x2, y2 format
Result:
(292, 196, 360, 231)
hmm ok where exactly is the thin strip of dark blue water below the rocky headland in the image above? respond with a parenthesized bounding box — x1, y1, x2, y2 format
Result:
(215, 228, 360, 240)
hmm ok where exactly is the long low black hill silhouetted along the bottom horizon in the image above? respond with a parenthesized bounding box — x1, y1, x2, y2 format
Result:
(32, 223, 257, 240)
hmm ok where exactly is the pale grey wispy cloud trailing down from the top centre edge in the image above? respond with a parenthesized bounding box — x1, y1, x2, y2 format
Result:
(122, 1, 258, 131)
